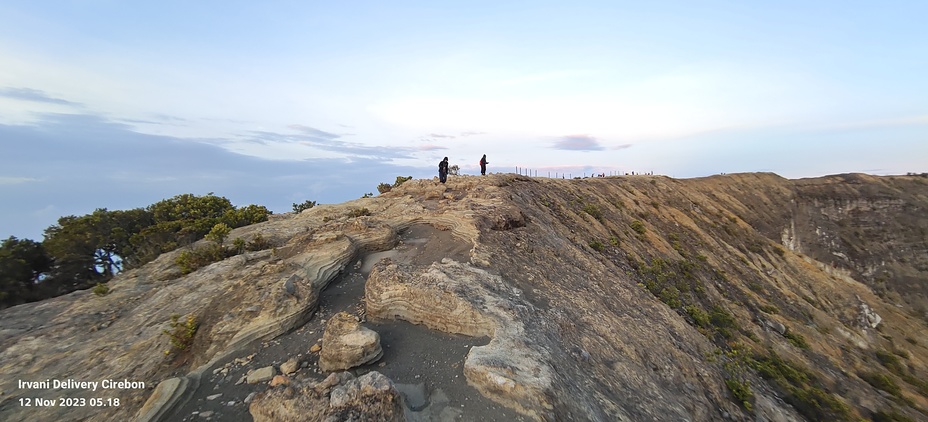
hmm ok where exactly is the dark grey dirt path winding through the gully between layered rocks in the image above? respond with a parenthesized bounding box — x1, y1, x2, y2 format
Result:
(168, 225, 526, 421)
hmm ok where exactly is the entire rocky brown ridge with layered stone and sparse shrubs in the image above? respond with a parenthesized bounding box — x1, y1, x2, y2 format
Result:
(0, 174, 928, 421)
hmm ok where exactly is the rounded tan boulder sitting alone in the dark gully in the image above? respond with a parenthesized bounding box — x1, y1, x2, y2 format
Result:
(319, 312, 383, 372)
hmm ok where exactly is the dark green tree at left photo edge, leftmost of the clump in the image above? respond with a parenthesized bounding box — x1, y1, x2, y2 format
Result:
(0, 236, 52, 307)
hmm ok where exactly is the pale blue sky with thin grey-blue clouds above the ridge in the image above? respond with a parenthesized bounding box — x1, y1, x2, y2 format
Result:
(0, 0, 928, 240)
